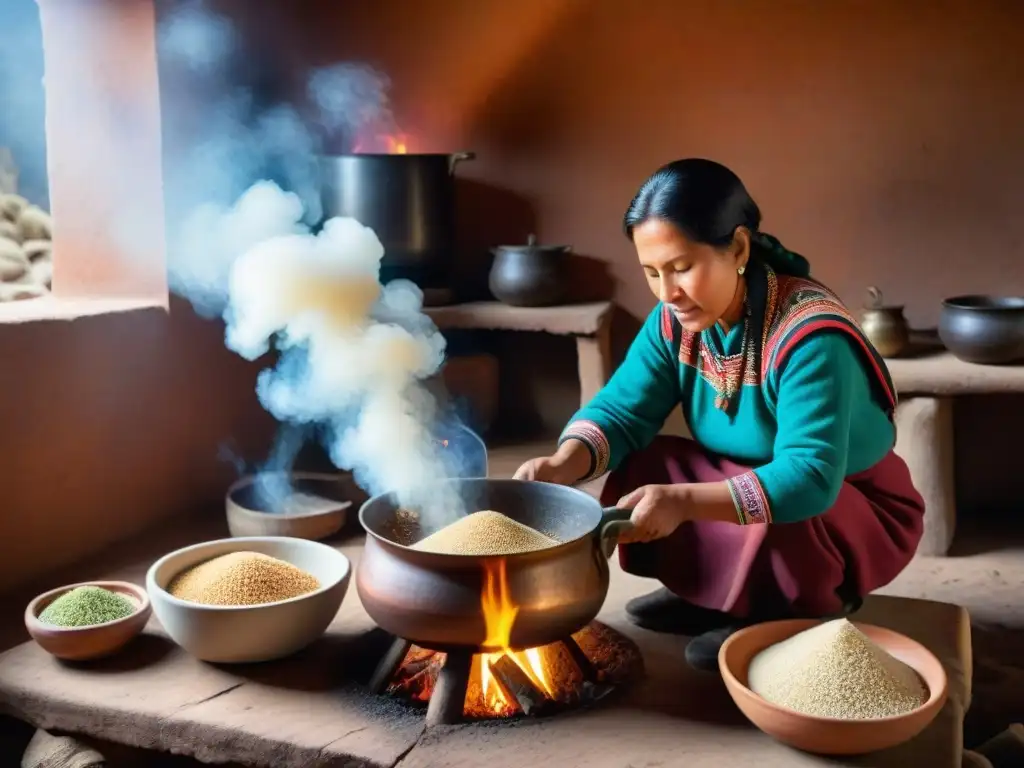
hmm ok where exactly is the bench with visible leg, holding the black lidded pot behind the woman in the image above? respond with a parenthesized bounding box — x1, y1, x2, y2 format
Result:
(424, 301, 614, 404)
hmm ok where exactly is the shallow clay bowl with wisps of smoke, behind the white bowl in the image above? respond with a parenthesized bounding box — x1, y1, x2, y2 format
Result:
(224, 472, 352, 541)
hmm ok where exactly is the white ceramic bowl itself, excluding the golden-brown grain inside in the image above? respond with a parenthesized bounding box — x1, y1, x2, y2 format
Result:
(145, 537, 352, 664)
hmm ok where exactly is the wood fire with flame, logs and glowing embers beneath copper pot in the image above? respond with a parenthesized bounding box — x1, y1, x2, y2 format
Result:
(385, 560, 643, 720)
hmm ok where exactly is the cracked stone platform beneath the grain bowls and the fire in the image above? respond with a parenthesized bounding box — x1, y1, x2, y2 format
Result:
(0, 518, 970, 768)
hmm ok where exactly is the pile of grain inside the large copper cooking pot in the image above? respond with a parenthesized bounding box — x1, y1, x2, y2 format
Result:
(413, 509, 558, 556)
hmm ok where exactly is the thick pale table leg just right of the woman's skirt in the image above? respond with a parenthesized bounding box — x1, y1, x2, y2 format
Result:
(896, 397, 956, 557)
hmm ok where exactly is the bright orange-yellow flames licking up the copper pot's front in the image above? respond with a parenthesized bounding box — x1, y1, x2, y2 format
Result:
(476, 559, 555, 715)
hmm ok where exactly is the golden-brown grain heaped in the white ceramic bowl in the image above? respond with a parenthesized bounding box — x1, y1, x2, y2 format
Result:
(167, 552, 321, 605)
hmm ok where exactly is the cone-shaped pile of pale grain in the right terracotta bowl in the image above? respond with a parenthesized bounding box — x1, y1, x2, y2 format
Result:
(748, 618, 928, 720)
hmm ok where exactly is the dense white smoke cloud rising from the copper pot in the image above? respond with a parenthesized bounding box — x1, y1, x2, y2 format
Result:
(204, 182, 458, 521)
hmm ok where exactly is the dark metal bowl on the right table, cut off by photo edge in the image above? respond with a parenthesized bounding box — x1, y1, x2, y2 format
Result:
(939, 296, 1024, 366)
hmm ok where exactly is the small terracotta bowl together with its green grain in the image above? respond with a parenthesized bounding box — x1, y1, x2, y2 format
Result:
(25, 582, 153, 662)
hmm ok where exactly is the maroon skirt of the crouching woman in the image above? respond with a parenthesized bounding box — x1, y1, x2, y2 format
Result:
(601, 436, 925, 617)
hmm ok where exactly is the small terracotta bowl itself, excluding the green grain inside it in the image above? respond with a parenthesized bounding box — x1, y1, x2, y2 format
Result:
(25, 582, 153, 662)
